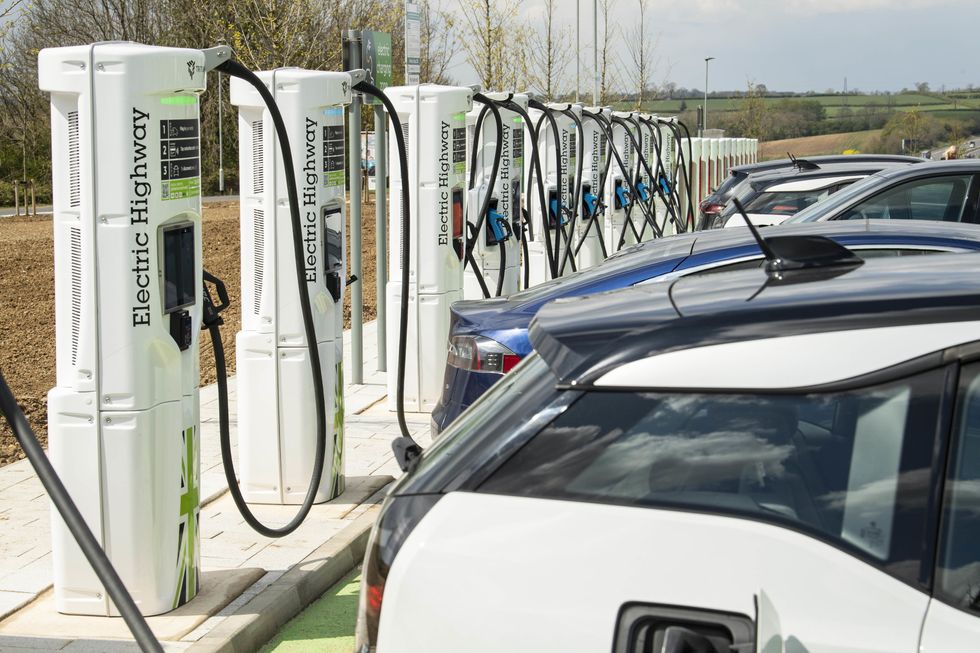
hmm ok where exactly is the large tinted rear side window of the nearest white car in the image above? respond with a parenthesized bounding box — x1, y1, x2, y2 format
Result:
(480, 370, 944, 583)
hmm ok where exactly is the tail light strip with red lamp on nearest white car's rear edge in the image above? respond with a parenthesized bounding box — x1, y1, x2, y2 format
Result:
(354, 494, 442, 653)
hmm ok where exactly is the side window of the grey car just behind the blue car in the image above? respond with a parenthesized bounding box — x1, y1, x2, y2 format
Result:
(838, 175, 973, 222)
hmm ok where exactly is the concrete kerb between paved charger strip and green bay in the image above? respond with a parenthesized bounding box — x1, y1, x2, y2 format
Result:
(187, 485, 388, 653)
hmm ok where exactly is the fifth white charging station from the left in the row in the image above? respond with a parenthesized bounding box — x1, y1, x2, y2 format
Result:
(524, 102, 582, 287)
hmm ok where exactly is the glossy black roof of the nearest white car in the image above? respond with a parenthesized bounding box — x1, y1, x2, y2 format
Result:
(529, 251, 980, 387)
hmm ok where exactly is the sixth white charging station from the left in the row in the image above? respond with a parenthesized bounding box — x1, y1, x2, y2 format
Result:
(574, 107, 612, 270)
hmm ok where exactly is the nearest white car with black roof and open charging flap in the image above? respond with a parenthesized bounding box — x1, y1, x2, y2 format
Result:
(356, 241, 980, 653)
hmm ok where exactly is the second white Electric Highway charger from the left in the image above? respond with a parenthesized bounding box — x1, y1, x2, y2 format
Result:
(231, 68, 351, 504)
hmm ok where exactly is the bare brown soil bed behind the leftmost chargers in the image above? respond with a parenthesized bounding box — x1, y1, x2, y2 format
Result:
(0, 202, 377, 465)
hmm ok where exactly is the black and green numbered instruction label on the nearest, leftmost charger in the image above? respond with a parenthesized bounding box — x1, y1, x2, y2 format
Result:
(160, 118, 201, 200)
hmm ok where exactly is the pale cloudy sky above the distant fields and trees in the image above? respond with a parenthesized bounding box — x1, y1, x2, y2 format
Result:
(442, 0, 980, 93)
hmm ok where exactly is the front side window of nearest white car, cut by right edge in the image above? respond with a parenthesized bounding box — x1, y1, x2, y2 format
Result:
(935, 365, 980, 612)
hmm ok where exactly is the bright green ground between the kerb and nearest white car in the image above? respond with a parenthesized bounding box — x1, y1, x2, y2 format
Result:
(261, 569, 361, 653)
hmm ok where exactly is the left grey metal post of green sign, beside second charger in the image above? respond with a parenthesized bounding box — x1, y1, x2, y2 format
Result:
(347, 30, 364, 385)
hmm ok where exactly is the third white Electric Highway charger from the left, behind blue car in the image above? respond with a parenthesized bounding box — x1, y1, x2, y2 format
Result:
(385, 84, 473, 412)
